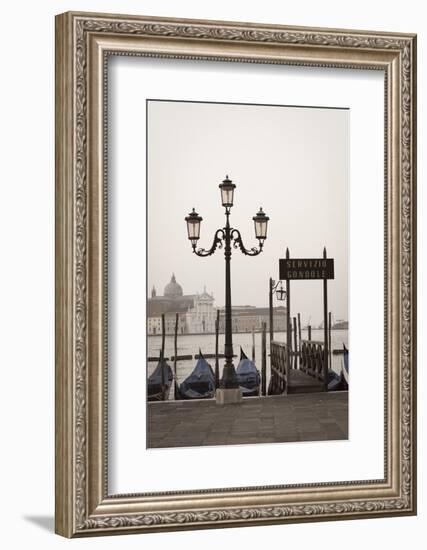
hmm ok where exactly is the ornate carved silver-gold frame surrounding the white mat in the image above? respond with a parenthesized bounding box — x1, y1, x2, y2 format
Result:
(55, 12, 416, 537)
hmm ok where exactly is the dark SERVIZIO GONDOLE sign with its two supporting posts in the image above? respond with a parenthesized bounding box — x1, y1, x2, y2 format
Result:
(279, 247, 334, 391)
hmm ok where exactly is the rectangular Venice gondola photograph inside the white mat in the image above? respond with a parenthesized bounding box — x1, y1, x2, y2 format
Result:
(147, 98, 351, 448)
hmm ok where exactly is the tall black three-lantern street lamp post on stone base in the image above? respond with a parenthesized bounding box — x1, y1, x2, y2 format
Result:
(185, 176, 269, 398)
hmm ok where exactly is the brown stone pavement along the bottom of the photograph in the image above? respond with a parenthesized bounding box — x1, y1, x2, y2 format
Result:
(147, 392, 348, 448)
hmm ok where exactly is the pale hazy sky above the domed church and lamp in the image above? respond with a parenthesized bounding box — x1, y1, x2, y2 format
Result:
(148, 101, 349, 325)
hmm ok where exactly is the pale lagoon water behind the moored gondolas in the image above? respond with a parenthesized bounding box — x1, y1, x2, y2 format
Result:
(148, 329, 349, 399)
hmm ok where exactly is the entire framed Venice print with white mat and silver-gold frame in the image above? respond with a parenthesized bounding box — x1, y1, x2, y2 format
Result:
(56, 12, 416, 537)
